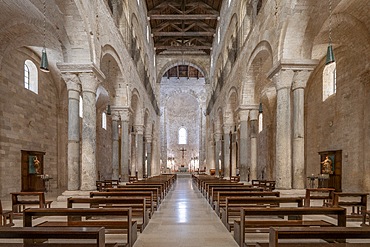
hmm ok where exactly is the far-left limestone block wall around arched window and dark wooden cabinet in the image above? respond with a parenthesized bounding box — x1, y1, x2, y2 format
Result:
(0, 51, 67, 196)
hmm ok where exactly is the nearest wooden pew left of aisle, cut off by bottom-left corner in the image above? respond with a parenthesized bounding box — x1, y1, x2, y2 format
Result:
(0, 227, 114, 247)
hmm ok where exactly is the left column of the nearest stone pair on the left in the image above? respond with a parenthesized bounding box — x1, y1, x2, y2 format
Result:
(63, 73, 81, 190)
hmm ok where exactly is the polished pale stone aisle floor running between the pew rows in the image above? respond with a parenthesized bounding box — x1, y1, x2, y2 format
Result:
(134, 175, 238, 247)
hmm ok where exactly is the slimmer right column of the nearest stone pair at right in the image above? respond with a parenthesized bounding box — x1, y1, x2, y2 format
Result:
(292, 71, 311, 189)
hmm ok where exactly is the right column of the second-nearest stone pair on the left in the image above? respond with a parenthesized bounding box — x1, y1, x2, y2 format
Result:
(119, 109, 130, 182)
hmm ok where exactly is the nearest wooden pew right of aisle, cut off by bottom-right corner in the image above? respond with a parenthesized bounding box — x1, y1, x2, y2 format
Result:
(257, 227, 370, 247)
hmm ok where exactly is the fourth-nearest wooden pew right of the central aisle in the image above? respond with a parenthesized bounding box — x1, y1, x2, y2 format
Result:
(214, 191, 280, 217)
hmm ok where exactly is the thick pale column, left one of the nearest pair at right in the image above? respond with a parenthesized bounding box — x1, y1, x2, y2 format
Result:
(273, 70, 294, 189)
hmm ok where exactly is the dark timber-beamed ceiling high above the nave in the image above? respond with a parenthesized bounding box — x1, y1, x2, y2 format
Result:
(146, 0, 222, 54)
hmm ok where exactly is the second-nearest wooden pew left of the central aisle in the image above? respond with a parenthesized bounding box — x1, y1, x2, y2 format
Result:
(23, 208, 137, 247)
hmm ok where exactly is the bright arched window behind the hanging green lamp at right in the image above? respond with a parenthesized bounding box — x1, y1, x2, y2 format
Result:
(322, 62, 337, 101)
